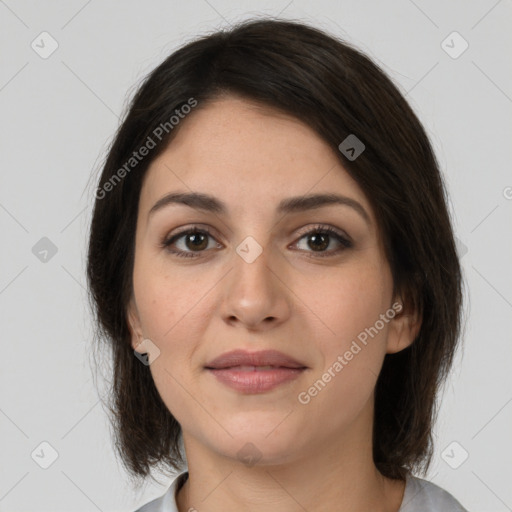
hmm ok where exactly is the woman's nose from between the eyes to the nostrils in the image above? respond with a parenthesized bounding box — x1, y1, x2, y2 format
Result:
(221, 237, 292, 331)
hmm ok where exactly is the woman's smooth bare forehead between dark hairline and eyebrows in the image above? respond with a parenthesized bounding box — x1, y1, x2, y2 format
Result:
(140, 97, 372, 224)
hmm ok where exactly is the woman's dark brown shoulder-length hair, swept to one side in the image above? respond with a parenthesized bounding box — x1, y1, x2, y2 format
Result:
(87, 18, 463, 479)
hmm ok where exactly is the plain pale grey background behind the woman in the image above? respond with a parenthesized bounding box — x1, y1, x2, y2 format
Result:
(0, 0, 512, 512)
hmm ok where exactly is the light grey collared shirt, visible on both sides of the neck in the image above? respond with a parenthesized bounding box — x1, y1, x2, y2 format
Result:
(134, 470, 468, 512)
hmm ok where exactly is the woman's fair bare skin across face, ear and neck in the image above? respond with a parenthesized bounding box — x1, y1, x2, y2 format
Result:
(128, 96, 420, 512)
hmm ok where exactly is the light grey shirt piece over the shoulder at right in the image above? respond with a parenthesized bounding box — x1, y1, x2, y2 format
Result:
(398, 475, 468, 512)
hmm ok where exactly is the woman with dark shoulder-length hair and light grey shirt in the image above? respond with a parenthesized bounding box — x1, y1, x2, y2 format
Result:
(88, 19, 465, 512)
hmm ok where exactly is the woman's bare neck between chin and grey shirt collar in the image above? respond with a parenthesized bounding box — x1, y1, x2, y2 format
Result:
(177, 400, 405, 512)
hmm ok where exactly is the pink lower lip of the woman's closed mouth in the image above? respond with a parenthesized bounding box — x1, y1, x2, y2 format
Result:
(208, 367, 305, 393)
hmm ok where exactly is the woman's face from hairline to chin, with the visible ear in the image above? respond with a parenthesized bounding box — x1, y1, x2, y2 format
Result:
(129, 97, 417, 464)
